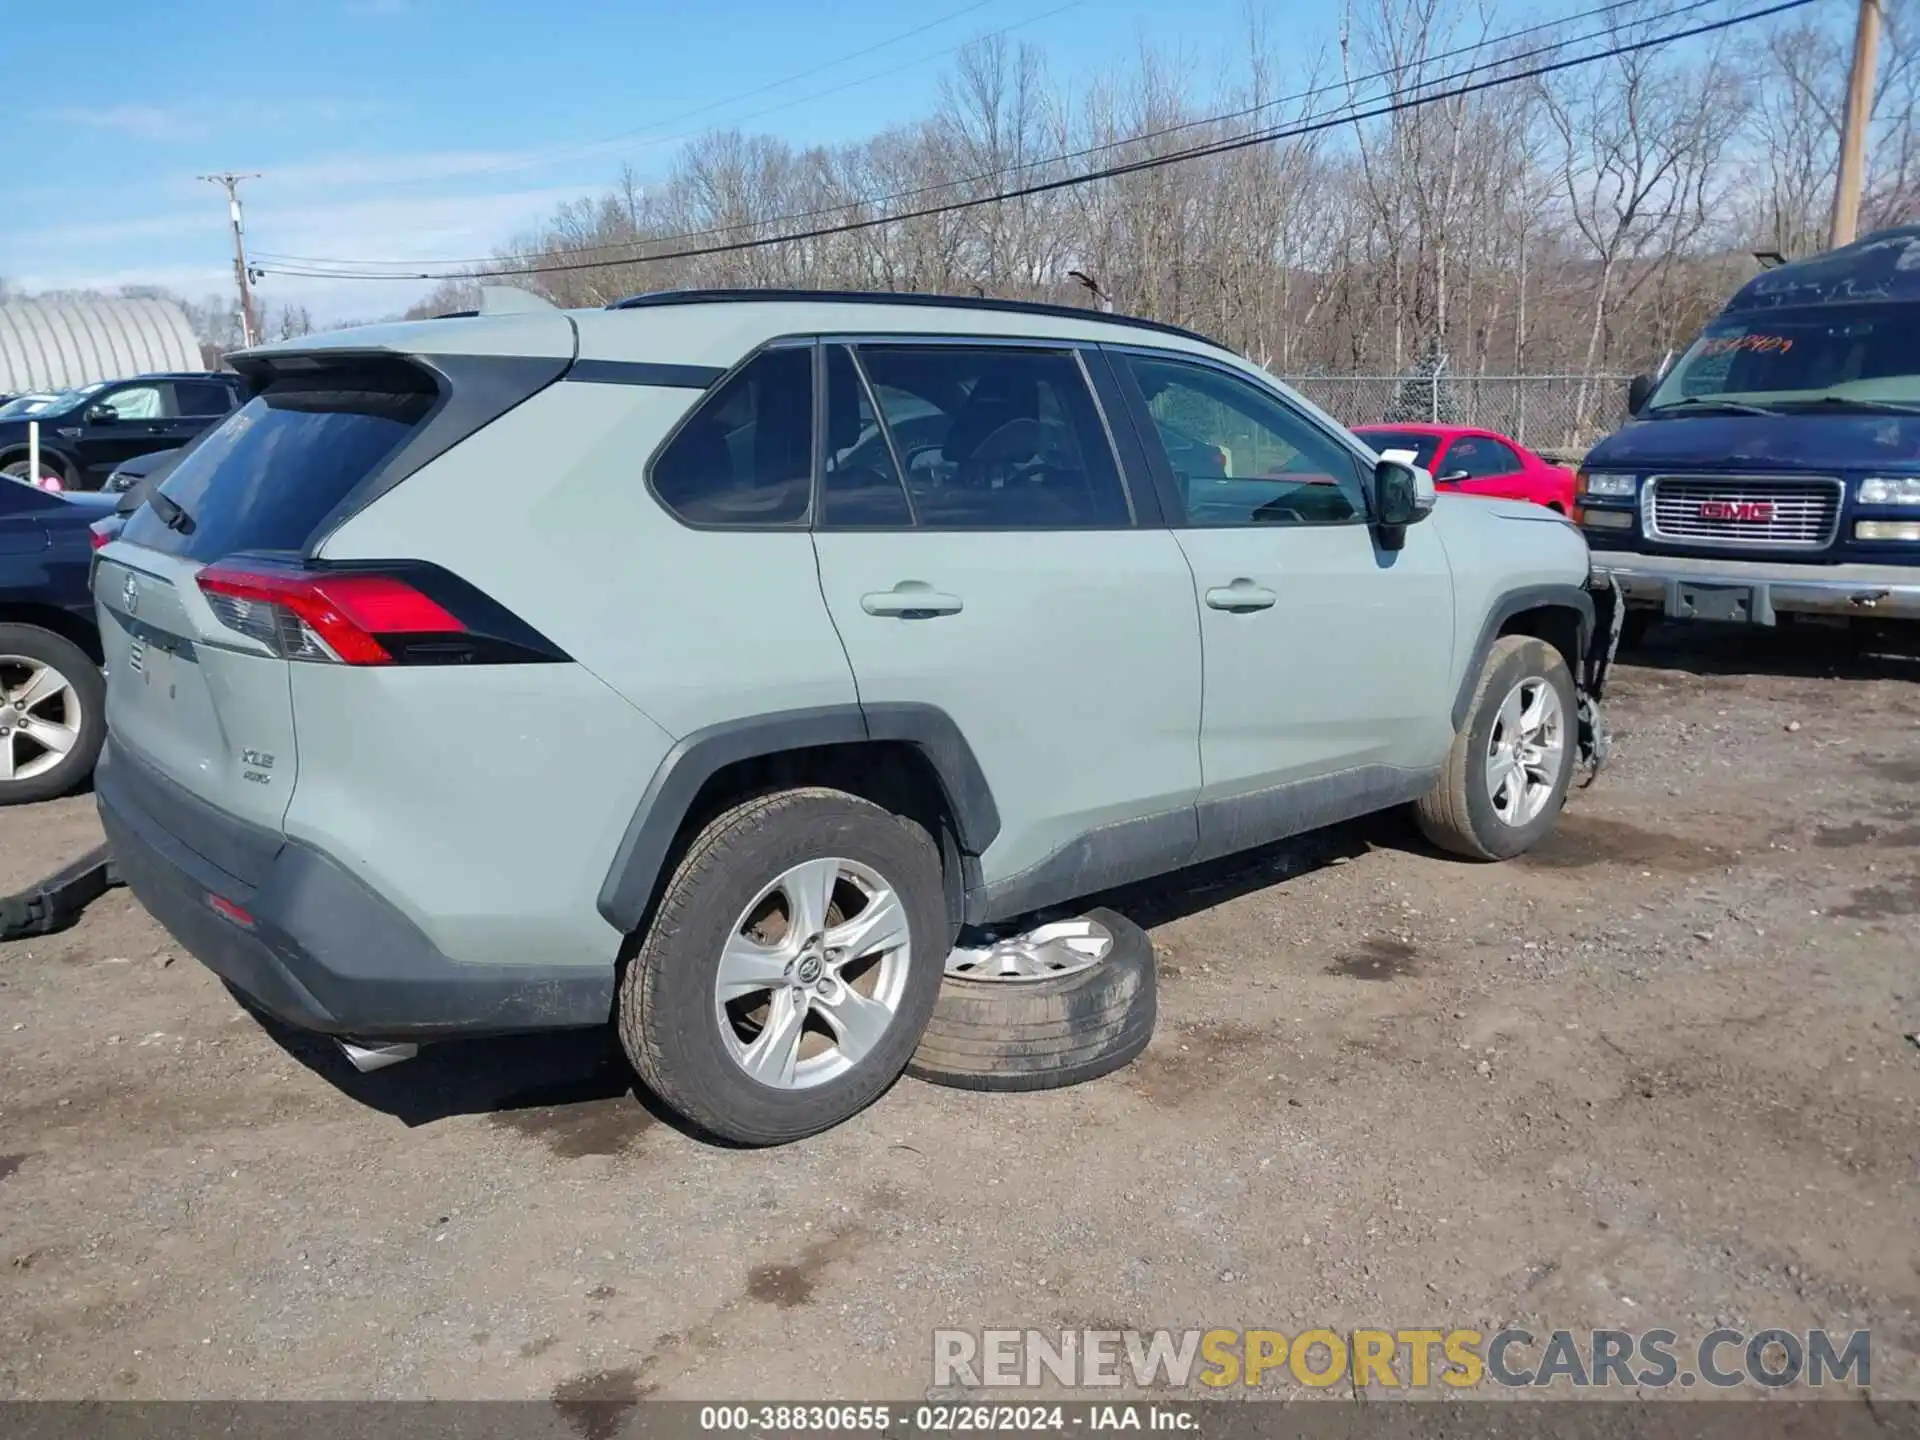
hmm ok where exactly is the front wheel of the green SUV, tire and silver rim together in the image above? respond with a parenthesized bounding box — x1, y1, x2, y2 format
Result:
(1415, 636, 1574, 860)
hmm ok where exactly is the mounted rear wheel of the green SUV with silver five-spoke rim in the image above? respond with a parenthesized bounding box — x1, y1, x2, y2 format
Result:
(616, 787, 950, 1144)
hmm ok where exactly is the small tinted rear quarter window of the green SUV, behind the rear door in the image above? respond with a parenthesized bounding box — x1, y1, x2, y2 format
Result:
(649, 346, 814, 528)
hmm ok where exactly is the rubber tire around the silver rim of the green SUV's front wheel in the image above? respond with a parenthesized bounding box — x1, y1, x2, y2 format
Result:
(1415, 636, 1578, 860)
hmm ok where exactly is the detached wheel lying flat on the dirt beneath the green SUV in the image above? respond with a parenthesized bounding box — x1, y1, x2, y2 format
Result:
(906, 910, 1158, 1091)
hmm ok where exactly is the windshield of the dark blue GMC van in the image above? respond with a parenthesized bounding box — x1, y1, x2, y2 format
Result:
(1644, 303, 1920, 415)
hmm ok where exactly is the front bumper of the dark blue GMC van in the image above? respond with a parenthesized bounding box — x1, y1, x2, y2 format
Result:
(1594, 549, 1920, 626)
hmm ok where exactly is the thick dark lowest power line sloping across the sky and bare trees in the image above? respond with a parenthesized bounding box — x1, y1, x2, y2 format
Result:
(276, 0, 1814, 280)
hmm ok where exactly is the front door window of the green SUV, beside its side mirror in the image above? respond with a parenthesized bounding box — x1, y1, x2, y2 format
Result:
(1125, 355, 1367, 526)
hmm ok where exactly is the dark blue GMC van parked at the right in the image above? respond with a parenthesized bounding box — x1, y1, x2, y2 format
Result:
(1574, 225, 1920, 626)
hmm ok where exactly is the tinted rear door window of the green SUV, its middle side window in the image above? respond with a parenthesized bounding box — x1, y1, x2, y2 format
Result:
(852, 344, 1133, 530)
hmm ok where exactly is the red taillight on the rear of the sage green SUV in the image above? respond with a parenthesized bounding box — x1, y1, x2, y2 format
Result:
(200, 564, 467, 664)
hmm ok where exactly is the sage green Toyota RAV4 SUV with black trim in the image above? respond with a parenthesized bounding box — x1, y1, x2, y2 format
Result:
(94, 292, 1594, 1142)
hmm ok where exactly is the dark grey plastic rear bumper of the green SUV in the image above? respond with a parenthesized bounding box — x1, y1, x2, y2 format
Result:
(94, 739, 614, 1041)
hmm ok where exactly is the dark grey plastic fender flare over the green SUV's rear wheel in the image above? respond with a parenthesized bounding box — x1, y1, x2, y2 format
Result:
(597, 703, 1000, 935)
